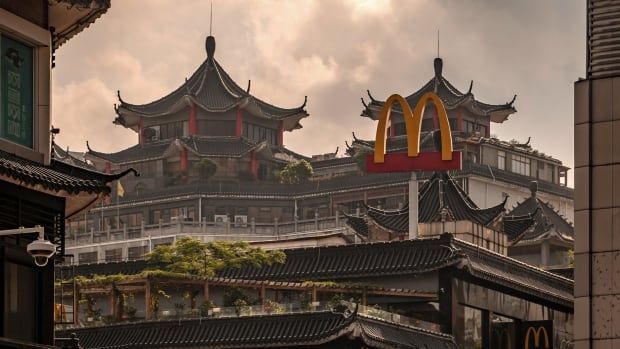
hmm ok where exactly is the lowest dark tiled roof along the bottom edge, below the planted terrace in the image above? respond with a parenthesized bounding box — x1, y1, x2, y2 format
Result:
(56, 309, 457, 349)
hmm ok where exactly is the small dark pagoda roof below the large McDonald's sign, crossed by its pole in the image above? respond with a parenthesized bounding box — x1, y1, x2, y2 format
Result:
(348, 173, 506, 235)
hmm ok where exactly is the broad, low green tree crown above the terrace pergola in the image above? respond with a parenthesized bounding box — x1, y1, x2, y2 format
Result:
(146, 237, 286, 277)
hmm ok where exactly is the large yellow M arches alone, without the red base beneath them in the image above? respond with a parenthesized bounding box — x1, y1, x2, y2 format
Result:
(374, 92, 453, 163)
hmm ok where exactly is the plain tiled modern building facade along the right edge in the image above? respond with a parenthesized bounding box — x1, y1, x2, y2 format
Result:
(574, 0, 620, 348)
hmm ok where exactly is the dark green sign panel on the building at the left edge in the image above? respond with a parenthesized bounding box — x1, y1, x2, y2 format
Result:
(0, 36, 33, 148)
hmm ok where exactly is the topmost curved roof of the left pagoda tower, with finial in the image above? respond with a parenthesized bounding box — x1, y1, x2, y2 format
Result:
(114, 36, 308, 131)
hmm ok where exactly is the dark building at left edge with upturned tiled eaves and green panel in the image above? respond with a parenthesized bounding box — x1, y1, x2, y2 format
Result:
(0, 0, 137, 348)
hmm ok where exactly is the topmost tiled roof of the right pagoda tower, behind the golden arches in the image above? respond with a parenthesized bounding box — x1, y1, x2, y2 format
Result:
(361, 58, 517, 123)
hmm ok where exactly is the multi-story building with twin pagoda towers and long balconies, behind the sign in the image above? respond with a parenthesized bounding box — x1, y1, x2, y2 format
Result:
(57, 37, 573, 270)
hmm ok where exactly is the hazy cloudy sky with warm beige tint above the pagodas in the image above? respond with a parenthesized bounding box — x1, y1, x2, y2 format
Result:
(52, 0, 585, 184)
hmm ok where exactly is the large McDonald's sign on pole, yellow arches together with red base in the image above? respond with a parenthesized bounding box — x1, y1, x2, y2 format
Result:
(366, 92, 461, 172)
